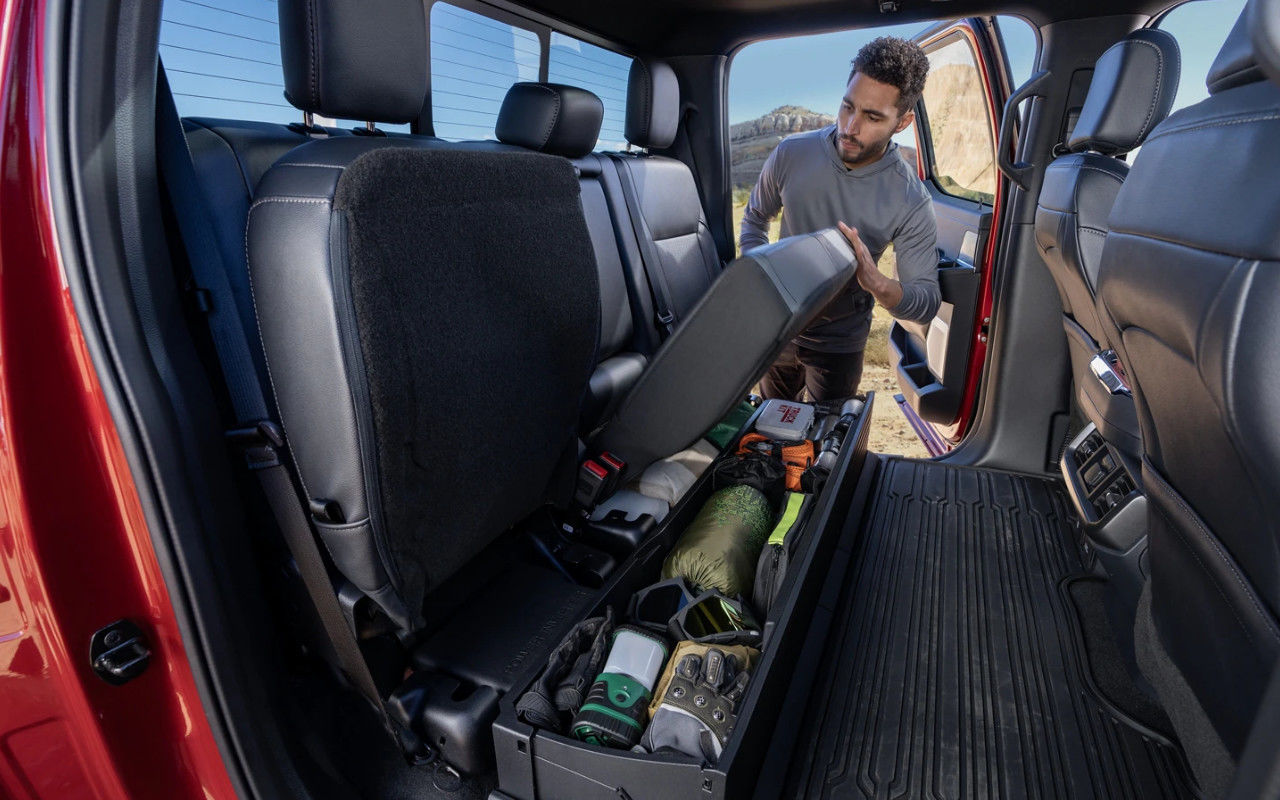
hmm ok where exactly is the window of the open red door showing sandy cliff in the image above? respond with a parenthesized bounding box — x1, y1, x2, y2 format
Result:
(923, 33, 996, 204)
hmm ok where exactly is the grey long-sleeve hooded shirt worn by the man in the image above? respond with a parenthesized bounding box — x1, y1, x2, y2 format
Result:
(739, 125, 942, 352)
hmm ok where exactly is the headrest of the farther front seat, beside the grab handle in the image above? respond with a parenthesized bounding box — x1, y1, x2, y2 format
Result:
(1066, 28, 1181, 155)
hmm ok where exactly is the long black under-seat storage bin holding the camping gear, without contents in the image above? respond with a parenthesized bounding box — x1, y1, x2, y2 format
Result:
(493, 396, 874, 800)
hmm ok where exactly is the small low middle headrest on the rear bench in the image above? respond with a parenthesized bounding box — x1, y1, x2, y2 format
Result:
(494, 82, 604, 159)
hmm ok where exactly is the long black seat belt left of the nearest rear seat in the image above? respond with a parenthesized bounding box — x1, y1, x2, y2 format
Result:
(156, 67, 401, 744)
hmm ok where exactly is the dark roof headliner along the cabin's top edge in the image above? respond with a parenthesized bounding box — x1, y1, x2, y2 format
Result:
(520, 0, 1171, 55)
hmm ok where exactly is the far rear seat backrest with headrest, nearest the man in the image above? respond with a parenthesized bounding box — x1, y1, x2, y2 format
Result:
(605, 59, 722, 335)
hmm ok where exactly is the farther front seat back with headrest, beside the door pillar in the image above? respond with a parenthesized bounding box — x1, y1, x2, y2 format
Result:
(1036, 29, 1180, 453)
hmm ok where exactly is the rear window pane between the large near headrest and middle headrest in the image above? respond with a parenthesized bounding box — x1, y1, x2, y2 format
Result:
(429, 3, 541, 140)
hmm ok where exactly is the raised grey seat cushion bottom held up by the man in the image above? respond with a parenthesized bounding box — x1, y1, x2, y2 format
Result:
(593, 229, 854, 476)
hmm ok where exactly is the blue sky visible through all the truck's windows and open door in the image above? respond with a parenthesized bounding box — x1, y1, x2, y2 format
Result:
(160, 0, 1244, 136)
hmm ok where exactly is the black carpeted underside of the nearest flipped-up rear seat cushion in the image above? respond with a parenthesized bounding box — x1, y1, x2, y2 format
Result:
(335, 148, 599, 607)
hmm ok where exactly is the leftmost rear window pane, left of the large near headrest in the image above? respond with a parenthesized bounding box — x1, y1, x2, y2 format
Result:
(160, 0, 408, 133)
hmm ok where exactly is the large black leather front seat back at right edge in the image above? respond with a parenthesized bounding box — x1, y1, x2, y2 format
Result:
(1098, 0, 1280, 796)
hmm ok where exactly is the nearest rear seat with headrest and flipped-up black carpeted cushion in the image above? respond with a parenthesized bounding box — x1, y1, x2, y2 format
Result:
(247, 0, 599, 631)
